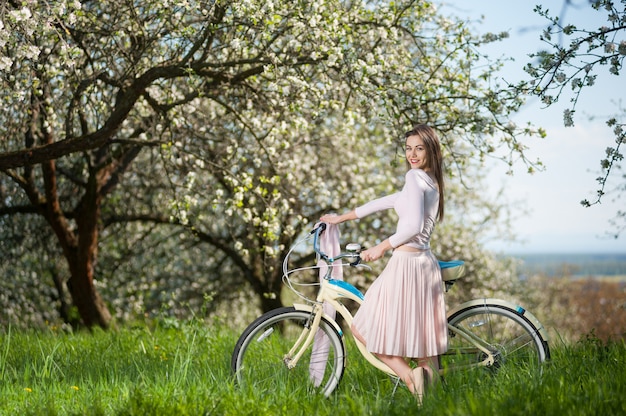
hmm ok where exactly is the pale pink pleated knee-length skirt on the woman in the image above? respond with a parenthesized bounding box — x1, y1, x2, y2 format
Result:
(352, 250, 448, 358)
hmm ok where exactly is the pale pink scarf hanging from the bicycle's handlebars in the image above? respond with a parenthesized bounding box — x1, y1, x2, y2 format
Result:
(309, 223, 343, 387)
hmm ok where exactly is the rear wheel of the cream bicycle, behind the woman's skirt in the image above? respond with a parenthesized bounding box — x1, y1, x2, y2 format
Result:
(442, 304, 550, 369)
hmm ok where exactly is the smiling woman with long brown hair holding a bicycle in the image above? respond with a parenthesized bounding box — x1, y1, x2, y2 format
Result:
(320, 125, 448, 401)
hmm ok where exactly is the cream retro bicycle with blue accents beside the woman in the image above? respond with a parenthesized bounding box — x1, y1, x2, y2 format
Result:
(231, 223, 550, 397)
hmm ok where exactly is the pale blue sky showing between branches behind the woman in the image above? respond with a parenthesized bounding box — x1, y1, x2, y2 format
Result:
(436, 0, 626, 254)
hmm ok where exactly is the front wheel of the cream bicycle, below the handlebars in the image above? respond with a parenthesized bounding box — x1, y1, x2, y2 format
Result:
(231, 307, 345, 397)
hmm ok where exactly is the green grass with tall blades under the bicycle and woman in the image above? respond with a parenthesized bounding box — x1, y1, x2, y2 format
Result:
(0, 322, 626, 416)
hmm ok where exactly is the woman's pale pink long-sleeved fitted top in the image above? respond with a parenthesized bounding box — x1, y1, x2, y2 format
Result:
(355, 169, 439, 250)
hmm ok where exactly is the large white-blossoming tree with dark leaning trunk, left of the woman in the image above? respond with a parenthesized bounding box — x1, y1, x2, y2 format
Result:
(0, 0, 541, 327)
